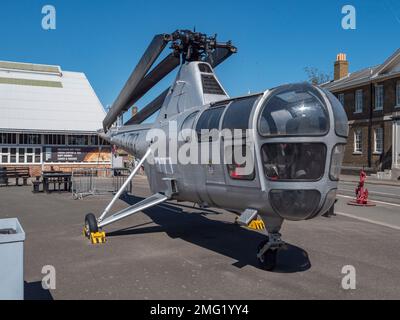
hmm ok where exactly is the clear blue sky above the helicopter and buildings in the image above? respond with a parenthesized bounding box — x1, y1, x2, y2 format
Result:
(0, 0, 400, 115)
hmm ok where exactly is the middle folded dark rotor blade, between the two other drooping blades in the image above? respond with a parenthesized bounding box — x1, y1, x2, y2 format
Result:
(123, 53, 181, 111)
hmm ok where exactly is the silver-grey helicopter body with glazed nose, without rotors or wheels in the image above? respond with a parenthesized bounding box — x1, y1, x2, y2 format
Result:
(103, 61, 348, 229)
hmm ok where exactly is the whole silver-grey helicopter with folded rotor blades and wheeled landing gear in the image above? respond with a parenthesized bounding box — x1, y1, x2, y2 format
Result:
(84, 30, 349, 270)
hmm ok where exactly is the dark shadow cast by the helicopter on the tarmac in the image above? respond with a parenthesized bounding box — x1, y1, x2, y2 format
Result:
(107, 195, 311, 273)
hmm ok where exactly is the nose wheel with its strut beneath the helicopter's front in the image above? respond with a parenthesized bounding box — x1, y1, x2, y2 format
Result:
(257, 233, 284, 271)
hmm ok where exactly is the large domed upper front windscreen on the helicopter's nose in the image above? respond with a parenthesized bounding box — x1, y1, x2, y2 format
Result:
(259, 84, 329, 136)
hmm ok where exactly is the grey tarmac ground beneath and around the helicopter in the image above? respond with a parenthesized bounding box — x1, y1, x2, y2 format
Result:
(0, 177, 400, 299)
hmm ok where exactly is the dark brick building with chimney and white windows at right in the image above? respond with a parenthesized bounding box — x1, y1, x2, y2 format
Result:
(322, 49, 400, 178)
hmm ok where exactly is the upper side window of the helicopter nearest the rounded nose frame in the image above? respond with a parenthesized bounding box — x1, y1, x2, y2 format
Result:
(222, 96, 259, 130)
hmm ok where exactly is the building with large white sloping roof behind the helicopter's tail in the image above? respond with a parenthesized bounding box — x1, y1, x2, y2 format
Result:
(0, 61, 111, 176)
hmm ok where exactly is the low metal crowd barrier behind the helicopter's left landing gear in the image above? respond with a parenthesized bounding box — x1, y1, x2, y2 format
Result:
(72, 168, 132, 199)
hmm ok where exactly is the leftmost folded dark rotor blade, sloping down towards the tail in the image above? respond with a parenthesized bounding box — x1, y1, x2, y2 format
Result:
(103, 34, 167, 130)
